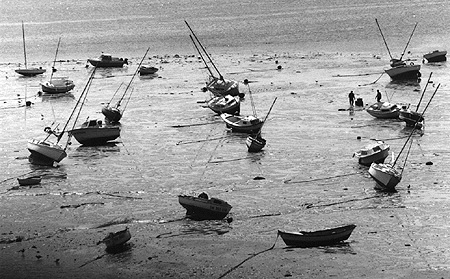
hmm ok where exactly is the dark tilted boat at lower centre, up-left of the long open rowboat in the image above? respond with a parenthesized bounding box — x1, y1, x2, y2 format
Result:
(178, 192, 232, 220)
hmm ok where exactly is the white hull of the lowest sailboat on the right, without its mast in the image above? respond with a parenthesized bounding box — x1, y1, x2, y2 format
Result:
(369, 163, 402, 192)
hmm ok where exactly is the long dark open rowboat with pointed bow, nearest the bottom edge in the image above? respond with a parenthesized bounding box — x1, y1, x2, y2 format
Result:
(278, 224, 356, 248)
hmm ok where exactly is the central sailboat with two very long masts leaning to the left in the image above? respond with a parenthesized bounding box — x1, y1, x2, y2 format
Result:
(184, 20, 240, 96)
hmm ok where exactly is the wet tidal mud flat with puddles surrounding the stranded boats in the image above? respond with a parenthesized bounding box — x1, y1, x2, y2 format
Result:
(0, 52, 449, 278)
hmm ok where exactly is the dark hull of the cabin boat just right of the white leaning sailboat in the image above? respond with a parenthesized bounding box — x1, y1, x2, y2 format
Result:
(69, 127, 120, 146)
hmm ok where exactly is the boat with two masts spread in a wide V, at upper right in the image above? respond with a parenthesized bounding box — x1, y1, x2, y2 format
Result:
(375, 19, 421, 80)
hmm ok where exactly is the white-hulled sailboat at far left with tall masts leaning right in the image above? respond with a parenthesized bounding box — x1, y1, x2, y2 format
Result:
(27, 68, 96, 165)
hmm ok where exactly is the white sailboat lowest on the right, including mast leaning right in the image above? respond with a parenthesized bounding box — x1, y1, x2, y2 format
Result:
(369, 84, 440, 192)
